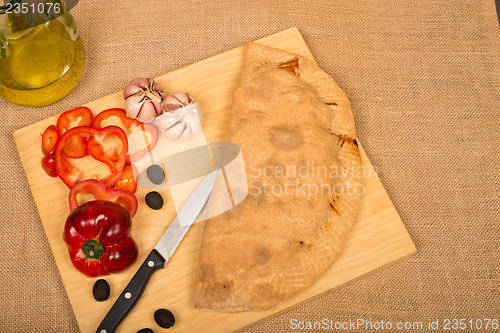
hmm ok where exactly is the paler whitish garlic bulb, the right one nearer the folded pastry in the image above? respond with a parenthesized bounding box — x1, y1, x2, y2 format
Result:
(155, 92, 202, 141)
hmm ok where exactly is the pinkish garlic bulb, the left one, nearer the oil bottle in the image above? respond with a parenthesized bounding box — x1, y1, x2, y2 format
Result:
(123, 78, 163, 122)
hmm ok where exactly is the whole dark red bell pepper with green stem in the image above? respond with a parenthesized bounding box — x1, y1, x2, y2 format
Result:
(63, 201, 138, 277)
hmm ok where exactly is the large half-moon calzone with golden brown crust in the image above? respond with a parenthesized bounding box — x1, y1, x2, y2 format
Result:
(195, 43, 360, 312)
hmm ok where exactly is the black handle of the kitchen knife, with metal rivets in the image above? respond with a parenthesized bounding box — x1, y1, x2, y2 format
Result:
(96, 249, 166, 333)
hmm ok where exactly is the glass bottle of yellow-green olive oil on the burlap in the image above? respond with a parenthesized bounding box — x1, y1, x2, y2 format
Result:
(0, 8, 85, 107)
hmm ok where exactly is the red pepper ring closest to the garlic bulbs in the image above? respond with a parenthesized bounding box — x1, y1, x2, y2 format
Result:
(92, 108, 158, 162)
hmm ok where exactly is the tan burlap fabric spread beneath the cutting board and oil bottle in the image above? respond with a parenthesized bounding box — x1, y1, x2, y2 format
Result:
(0, 0, 500, 332)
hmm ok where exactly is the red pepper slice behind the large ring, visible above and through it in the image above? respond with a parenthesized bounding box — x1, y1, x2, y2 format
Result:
(57, 106, 94, 158)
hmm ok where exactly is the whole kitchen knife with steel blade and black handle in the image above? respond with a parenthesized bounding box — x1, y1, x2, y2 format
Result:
(96, 168, 218, 333)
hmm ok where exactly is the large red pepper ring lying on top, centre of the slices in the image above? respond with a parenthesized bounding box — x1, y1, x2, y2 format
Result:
(54, 126, 128, 188)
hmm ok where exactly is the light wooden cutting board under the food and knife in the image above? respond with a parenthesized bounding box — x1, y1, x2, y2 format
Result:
(13, 28, 416, 332)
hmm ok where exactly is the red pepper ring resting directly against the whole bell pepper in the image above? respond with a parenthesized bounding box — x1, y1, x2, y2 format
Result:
(69, 179, 138, 217)
